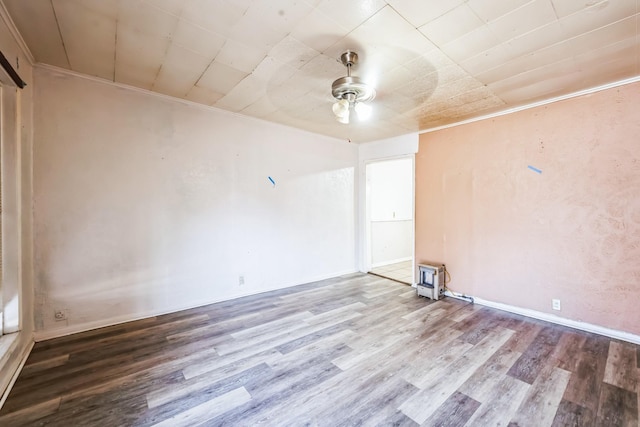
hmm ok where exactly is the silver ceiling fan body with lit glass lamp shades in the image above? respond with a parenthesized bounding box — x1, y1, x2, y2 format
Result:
(331, 50, 376, 124)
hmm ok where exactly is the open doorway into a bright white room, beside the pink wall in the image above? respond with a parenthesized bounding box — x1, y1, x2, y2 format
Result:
(366, 156, 414, 285)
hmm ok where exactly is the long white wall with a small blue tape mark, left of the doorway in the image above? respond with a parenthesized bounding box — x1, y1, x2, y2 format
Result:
(34, 68, 358, 338)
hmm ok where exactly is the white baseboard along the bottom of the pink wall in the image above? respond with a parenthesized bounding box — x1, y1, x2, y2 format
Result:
(445, 291, 640, 345)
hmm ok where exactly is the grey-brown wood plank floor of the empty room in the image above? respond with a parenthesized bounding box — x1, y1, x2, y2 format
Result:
(0, 274, 640, 427)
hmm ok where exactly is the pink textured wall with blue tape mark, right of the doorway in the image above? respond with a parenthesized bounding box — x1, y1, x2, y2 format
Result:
(416, 83, 640, 334)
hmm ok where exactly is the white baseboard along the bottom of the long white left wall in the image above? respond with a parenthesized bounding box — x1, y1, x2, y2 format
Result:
(33, 269, 358, 342)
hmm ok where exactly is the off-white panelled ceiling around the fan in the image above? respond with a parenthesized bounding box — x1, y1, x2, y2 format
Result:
(2, 0, 640, 142)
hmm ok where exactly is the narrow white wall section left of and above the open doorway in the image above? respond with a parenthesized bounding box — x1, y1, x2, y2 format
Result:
(357, 133, 418, 272)
